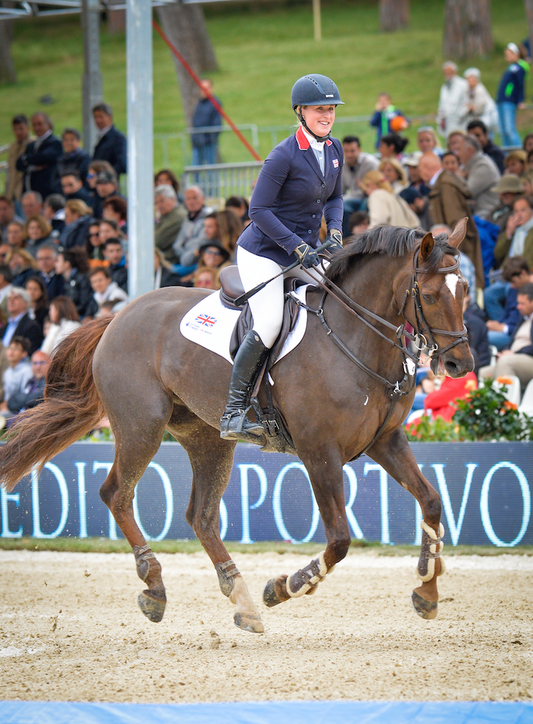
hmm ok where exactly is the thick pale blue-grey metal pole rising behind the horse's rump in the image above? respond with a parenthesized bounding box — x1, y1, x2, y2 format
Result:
(126, 0, 154, 299)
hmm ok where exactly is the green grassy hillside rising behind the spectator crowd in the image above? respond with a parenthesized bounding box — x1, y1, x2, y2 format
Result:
(0, 0, 531, 171)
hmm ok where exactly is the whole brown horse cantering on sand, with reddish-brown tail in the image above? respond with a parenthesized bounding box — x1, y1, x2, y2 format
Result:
(0, 219, 473, 633)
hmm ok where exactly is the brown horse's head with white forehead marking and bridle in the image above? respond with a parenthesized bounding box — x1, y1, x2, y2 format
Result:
(409, 218, 474, 377)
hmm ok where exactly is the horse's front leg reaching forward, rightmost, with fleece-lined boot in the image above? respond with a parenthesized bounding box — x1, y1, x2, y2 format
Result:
(368, 428, 445, 619)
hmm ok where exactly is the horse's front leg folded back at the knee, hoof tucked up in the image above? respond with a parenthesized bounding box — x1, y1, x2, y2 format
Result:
(263, 451, 350, 607)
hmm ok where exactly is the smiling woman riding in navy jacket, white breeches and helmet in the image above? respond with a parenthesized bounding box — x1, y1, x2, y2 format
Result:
(220, 74, 344, 440)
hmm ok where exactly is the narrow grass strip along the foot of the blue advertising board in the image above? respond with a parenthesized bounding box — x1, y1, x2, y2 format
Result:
(0, 538, 533, 556)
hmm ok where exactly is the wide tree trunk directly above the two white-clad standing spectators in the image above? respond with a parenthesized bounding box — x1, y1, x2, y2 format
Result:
(443, 0, 494, 60)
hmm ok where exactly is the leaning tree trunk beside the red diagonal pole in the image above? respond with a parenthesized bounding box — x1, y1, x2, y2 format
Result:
(157, 3, 218, 127)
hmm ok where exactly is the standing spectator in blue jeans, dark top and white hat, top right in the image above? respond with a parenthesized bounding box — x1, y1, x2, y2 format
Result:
(496, 43, 529, 146)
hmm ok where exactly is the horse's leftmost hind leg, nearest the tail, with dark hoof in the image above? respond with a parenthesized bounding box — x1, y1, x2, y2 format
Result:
(100, 394, 172, 623)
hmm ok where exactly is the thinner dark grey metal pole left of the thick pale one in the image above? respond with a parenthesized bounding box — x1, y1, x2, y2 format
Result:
(81, 0, 102, 155)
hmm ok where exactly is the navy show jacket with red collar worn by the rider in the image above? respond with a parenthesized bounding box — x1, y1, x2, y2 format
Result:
(237, 127, 344, 266)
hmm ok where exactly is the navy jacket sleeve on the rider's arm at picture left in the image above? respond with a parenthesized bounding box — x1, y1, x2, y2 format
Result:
(249, 146, 302, 254)
